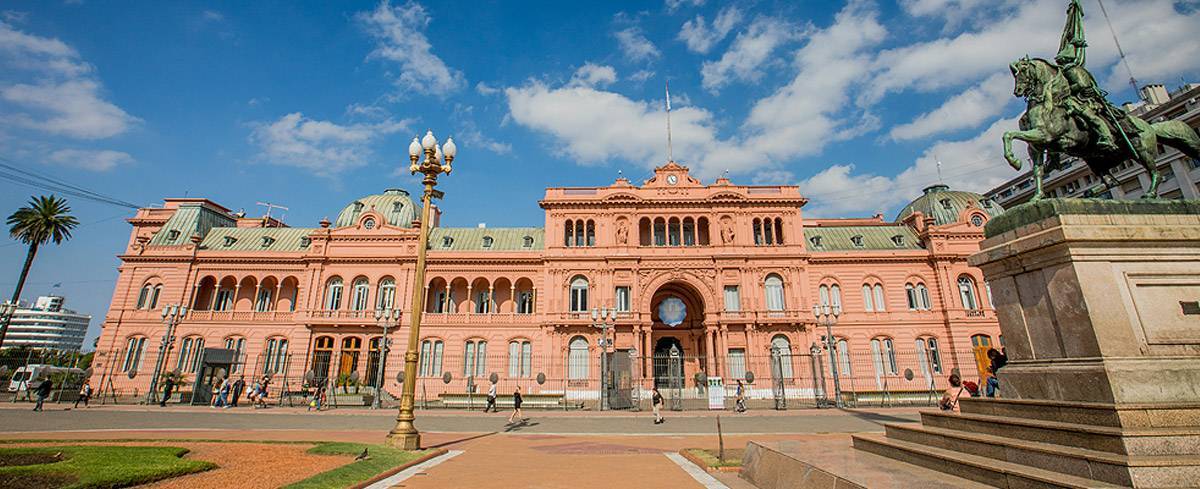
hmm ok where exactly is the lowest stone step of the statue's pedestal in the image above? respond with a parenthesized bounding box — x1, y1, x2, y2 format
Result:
(853, 433, 1122, 489)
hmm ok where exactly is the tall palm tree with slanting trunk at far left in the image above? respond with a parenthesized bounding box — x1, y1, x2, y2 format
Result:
(0, 195, 79, 348)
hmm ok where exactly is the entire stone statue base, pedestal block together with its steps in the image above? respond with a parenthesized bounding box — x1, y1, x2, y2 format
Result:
(854, 199, 1200, 488)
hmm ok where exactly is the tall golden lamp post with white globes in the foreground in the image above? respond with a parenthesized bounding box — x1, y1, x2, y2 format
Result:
(388, 131, 457, 449)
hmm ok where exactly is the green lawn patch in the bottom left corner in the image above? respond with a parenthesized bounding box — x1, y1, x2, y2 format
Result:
(0, 446, 216, 489)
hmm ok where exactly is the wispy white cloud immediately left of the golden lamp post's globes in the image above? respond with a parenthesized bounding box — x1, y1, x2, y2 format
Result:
(250, 113, 409, 176)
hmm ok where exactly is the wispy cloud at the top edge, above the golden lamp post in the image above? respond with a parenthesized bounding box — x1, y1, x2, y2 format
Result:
(356, 0, 466, 96)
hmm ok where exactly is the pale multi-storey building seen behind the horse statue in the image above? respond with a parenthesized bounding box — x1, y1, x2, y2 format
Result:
(984, 84, 1200, 209)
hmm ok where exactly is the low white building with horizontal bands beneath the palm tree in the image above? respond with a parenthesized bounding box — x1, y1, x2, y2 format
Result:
(4, 296, 91, 350)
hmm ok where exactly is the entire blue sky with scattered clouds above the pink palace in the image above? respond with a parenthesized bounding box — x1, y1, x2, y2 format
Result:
(0, 0, 1200, 344)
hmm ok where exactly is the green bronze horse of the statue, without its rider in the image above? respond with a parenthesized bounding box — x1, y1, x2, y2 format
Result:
(1003, 56, 1200, 201)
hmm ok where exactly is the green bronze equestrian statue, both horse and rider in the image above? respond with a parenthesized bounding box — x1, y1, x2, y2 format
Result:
(1003, 0, 1200, 201)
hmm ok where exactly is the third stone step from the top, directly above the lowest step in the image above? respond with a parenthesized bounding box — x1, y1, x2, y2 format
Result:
(886, 423, 1200, 487)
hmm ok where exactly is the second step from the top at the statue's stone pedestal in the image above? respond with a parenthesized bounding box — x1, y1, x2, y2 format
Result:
(920, 411, 1200, 455)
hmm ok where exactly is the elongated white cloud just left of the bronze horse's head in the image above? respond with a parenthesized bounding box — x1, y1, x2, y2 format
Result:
(888, 72, 1015, 140)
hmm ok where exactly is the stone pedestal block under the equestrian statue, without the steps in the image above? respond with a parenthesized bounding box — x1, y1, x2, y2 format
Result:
(970, 199, 1200, 404)
